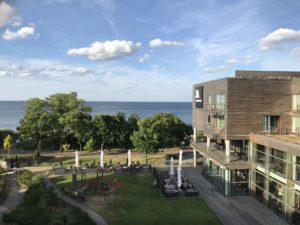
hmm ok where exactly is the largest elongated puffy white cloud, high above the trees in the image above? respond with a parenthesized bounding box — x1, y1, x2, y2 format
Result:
(67, 40, 141, 60)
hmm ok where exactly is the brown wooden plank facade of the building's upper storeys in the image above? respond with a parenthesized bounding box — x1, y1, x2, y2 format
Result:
(192, 71, 300, 140)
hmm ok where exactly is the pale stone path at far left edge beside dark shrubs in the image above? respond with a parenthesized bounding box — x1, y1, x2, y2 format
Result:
(0, 173, 27, 216)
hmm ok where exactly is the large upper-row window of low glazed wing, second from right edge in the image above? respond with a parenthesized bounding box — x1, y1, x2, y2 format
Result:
(270, 149, 286, 177)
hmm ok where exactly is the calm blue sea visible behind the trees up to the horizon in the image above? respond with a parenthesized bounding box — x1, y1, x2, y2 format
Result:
(0, 101, 192, 130)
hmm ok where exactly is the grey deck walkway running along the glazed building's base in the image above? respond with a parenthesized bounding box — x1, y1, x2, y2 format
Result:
(182, 167, 287, 225)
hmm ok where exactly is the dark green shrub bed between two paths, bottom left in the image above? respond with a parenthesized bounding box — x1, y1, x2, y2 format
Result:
(3, 181, 95, 225)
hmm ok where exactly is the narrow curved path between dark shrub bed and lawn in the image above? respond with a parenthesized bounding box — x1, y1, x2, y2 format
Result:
(44, 177, 108, 225)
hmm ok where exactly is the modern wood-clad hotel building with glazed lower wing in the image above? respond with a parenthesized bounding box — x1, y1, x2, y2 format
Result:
(191, 71, 300, 224)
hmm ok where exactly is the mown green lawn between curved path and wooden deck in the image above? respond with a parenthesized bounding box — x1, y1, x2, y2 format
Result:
(52, 173, 221, 225)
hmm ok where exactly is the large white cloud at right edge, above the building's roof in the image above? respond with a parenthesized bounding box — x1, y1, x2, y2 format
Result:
(259, 28, 300, 50)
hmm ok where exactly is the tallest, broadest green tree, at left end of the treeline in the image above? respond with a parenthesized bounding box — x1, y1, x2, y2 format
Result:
(17, 92, 91, 149)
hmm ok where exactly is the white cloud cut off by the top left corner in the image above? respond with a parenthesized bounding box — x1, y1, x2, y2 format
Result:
(0, 1, 20, 27)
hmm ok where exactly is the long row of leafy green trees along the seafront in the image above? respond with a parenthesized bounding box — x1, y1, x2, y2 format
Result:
(12, 92, 192, 152)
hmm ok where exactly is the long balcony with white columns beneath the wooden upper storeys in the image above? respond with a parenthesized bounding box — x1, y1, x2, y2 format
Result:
(191, 142, 250, 169)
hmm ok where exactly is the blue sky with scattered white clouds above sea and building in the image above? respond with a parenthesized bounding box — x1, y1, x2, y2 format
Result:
(0, 0, 300, 102)
